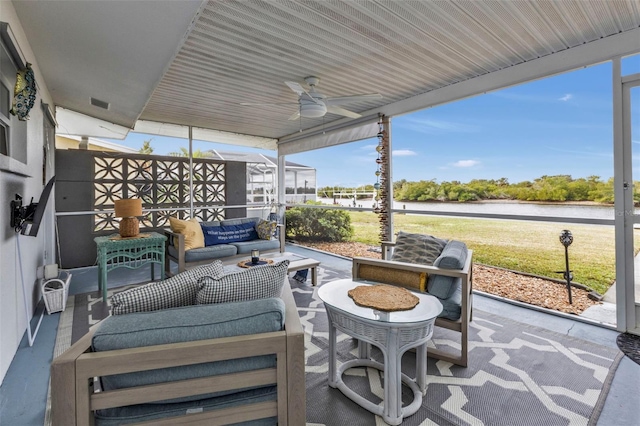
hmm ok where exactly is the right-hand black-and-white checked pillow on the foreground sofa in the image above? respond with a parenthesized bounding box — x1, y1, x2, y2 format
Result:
(196, 260, 289, 305)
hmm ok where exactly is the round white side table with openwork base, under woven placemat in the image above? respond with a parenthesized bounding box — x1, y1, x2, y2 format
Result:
(318, 280, 442, 425)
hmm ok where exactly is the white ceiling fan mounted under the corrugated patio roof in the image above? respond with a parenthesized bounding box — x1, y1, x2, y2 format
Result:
(240, 76, 382, 120)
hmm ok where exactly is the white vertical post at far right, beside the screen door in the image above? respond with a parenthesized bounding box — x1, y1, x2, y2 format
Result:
(612, 58, 634, 332)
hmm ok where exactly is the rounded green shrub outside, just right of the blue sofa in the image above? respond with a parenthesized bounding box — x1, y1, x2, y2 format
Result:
(285, 207, 353, 242)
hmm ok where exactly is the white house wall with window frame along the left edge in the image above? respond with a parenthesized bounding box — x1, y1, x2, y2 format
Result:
(0, 1, 54, 383)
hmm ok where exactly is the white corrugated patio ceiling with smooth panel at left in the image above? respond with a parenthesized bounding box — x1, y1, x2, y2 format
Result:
(14, 0, 640, 150)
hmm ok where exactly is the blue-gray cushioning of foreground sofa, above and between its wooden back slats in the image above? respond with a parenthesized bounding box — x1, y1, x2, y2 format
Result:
(91, 298, 285, 402)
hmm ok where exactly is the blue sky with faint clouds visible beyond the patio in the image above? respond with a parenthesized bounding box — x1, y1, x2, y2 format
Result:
(107, 56, 640, 187)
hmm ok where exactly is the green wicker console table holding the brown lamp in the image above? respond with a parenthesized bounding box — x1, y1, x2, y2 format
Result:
(93, 232, 167, 303)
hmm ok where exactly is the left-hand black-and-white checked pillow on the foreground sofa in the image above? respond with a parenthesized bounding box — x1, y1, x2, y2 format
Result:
(111, 260, 224, 315)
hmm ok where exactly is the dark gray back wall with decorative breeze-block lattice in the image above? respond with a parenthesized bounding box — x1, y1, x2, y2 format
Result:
(55, 149, 247, 269)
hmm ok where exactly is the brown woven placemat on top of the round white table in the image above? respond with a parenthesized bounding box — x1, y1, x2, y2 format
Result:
(347, 284, 420, 312)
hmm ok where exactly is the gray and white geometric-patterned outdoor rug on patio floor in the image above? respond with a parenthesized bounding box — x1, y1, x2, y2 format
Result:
(45, 268, 622, 426)
